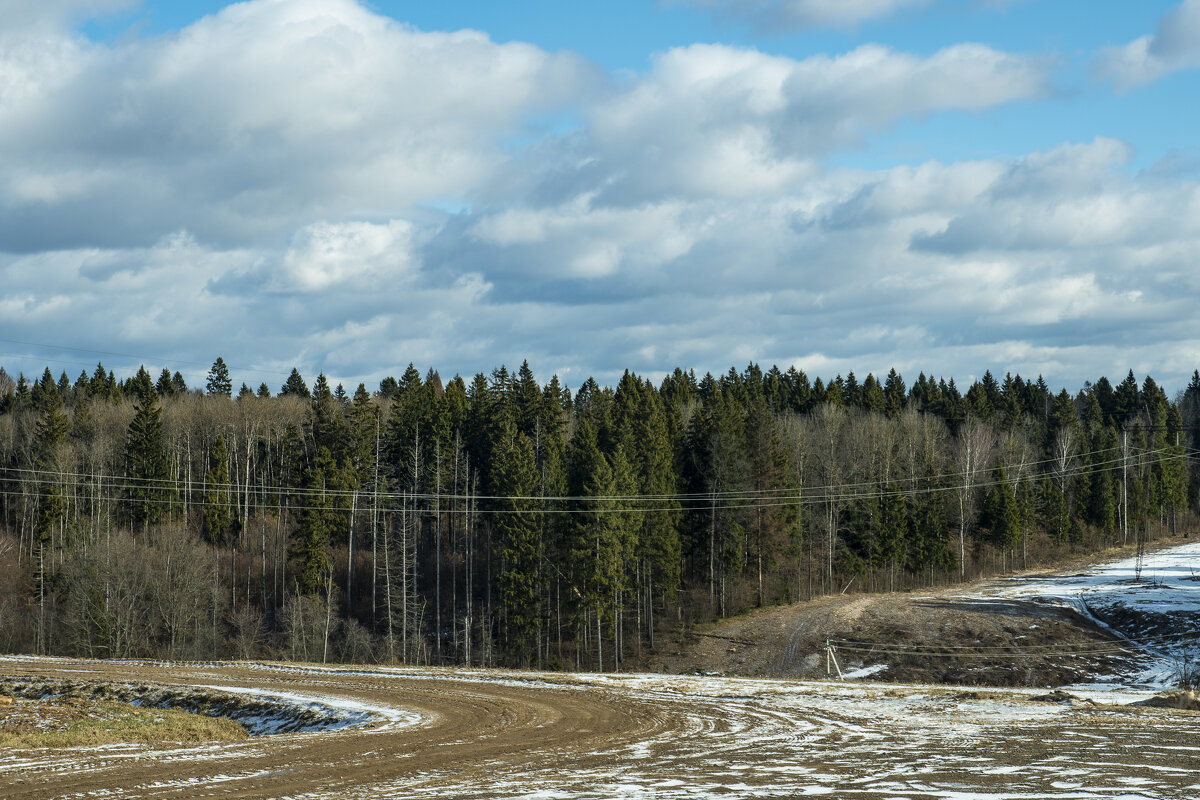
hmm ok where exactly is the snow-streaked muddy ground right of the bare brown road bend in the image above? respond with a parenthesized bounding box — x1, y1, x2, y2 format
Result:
(362, 674, 1200, 800)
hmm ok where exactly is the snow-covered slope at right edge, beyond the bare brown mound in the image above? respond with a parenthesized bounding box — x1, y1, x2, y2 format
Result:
(989, 542, 1200, 687)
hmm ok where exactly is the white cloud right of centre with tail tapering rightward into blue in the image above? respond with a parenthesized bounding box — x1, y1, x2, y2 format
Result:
(589, 44, 1051, 205)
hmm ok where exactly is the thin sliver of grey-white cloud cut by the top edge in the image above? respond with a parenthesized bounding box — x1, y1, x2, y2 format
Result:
(674, 0, 932, 30)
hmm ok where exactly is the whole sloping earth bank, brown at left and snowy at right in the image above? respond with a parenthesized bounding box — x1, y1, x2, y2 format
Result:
(635, 542, 1200, 687)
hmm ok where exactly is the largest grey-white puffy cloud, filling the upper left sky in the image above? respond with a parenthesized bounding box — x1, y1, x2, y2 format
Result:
(0, 0, 590, 251)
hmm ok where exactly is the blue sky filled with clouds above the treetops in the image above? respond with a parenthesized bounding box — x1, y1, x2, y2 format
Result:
(0, 0, 1200, 392)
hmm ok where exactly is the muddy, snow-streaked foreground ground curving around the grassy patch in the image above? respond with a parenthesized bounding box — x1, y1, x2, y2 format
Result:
(0, 658, 1200, 800)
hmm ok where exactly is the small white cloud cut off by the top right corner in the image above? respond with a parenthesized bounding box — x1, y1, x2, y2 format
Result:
(1097, 0, 1200, 91)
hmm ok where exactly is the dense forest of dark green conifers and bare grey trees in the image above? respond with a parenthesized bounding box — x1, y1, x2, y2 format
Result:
(0, 359, 1200, 670)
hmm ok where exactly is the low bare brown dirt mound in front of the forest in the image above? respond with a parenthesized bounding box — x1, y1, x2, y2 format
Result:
(640, 589, 1140, 686)
